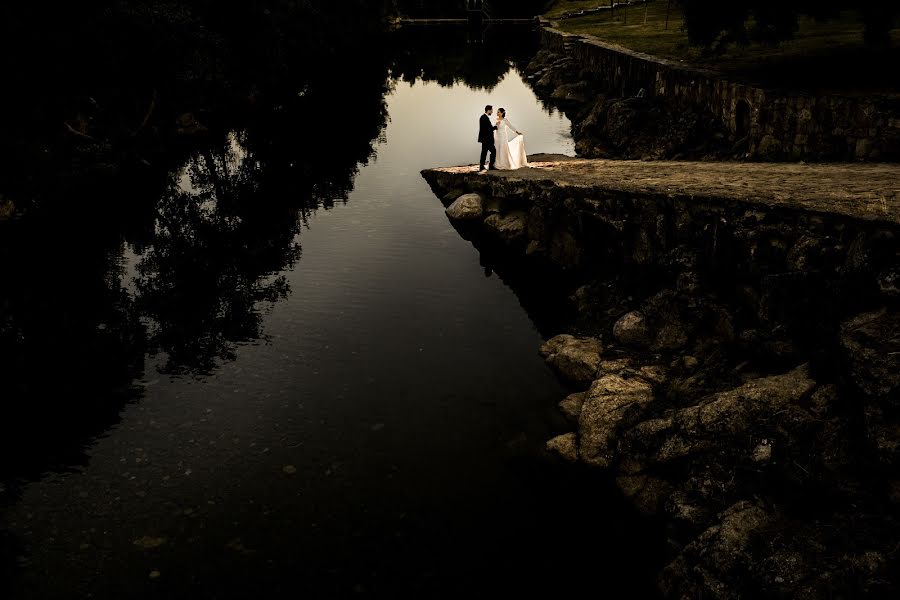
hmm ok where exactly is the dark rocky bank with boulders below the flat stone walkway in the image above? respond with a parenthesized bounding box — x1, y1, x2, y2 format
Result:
(423, 162, 900, 598)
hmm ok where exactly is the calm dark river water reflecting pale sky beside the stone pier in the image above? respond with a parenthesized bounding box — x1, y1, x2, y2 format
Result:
(0, 25, 659, 598)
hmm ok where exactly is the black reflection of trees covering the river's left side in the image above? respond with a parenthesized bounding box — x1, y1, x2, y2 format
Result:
(0, 22, 536, 491)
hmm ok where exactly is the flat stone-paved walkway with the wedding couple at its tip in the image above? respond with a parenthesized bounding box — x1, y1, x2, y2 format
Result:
(434, 155, 900, 223)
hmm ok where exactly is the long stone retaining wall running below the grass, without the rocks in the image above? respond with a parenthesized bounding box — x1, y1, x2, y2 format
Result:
(541, 21, 900, 161)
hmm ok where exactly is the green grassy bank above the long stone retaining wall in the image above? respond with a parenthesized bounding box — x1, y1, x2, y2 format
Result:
(544, 0, 900, 95)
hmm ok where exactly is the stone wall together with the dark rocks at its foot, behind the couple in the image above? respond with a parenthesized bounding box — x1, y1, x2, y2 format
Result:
(526, 17, 900, 162)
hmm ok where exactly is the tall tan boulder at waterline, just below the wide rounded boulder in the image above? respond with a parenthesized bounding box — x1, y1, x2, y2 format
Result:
(578, 375, 653, 468)
